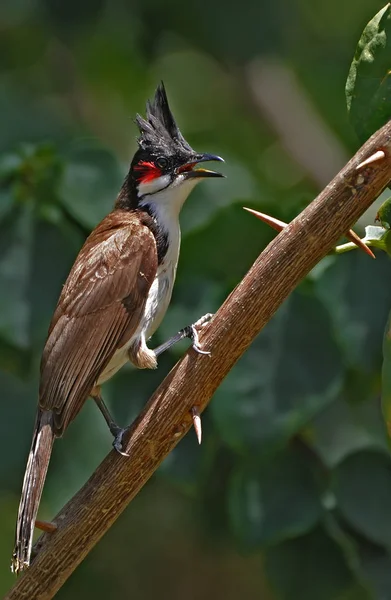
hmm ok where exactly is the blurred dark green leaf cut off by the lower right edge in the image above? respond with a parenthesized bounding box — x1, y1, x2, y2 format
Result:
(333, 451, 391, 548)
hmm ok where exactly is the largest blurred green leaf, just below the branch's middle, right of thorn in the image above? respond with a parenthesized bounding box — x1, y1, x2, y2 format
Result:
(211, 291, 343, 455)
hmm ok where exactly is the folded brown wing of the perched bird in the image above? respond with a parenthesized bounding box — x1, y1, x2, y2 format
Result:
(39, 210, 157, 434)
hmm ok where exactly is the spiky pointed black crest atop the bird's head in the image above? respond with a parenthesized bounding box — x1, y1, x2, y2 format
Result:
(136, 82, 194, 153)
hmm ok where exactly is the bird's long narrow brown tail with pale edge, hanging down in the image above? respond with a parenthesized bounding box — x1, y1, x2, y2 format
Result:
(11, 410, 54, 574)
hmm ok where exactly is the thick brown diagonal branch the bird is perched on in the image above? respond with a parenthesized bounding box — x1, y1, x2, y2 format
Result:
(6, 123, 391, 600)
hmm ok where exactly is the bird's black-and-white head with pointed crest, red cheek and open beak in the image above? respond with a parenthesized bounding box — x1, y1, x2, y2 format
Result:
(122, 83, 224, 212)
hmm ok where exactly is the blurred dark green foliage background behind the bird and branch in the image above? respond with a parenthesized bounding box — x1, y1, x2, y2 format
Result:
(0, 0, 391, 600)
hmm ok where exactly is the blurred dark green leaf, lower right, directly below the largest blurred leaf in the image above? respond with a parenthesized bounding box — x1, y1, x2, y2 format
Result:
(228, 449, 322, 550)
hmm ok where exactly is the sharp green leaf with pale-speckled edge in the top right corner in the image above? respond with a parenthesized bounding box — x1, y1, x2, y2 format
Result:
(345, 4, 391, 142)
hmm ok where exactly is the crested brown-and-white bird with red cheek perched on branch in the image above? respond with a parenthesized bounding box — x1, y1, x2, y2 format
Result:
(11, 82, 224, 574)
